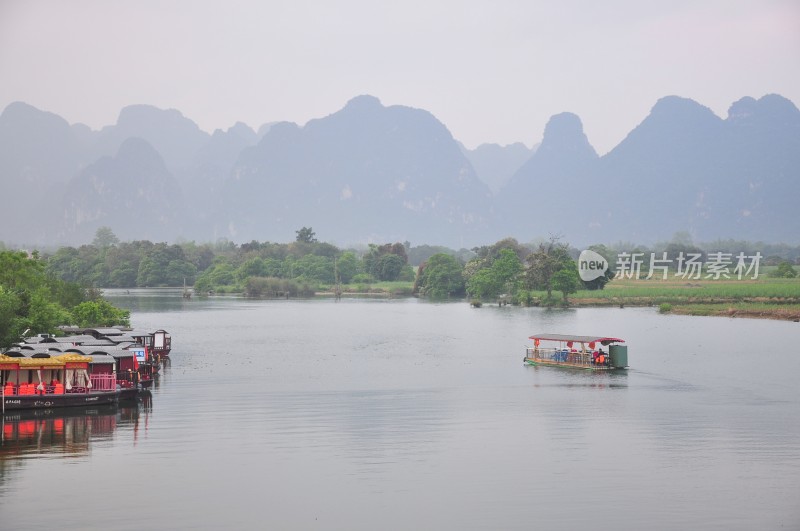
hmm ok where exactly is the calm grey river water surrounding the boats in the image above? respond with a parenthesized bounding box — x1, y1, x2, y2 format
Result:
(0, 290, 800, 530)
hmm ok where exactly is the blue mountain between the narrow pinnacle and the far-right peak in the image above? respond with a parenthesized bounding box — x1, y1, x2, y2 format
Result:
(592, 96, 729, 241)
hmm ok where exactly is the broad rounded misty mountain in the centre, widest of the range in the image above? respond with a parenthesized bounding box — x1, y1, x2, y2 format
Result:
(218, 96, 491, 242)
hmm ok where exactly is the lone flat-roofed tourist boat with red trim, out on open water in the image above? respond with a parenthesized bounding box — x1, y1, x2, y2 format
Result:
(524, 334, 628, 370)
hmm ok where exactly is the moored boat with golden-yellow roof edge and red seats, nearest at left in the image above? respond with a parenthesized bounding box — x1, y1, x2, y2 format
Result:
(0, 350, 120, 414)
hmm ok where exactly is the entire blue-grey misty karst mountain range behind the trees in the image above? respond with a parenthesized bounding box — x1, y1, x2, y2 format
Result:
(0, 95, 800, 248)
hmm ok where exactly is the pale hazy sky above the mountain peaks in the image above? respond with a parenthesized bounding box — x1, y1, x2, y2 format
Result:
(0, 0, 800, 154)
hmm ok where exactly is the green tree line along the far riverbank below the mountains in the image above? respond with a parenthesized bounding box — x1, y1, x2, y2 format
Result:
(32, 227, 800, 304)
